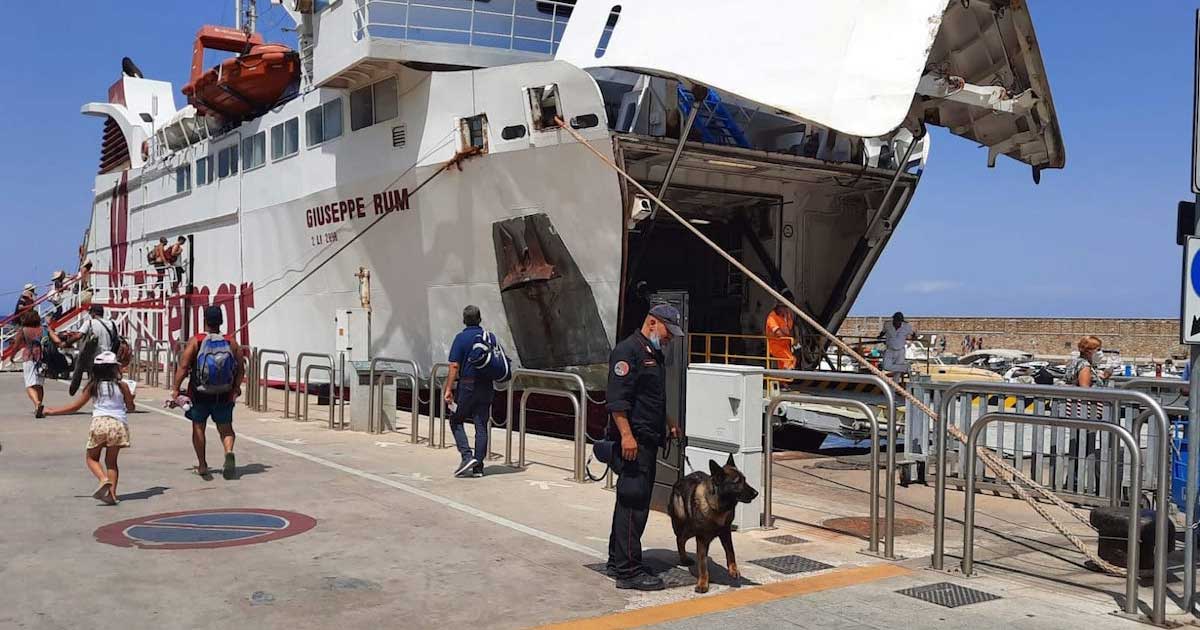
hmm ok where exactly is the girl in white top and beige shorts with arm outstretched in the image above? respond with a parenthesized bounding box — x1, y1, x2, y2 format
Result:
(46, 352, 134, 505)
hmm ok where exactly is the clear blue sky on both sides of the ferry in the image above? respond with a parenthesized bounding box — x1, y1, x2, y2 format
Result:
(0, 0, 1195, 317)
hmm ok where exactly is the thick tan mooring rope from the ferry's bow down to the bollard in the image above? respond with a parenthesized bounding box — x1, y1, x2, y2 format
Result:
(554, 116, 1136, 576)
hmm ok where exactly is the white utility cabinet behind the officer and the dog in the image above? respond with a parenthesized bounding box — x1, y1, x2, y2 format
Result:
(686, 364, 763, 530)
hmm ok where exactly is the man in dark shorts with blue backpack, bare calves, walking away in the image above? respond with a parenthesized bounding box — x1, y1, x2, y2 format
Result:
(172, 306, 242, 479)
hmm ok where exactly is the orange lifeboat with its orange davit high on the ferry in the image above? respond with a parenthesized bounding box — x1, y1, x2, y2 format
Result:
(182, 26, 300, 121)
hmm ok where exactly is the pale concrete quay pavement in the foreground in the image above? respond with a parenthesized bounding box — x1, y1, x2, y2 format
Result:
(0, 373, 1182, 630)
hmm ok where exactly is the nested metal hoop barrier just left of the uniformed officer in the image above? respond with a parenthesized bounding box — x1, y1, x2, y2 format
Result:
(504, 368, 588, 484)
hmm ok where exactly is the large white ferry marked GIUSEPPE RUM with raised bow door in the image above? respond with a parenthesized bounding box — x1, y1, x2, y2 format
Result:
(65, 0, 1066, 396)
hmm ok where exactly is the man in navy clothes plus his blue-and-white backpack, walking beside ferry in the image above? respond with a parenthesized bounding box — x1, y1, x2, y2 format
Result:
(442, 306, 511, 478)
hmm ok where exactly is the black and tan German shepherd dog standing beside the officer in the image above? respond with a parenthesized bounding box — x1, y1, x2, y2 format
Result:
(667, 455, 758, 593)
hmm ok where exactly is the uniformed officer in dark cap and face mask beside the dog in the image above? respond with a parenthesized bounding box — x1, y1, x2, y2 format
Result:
(607, 304, 683, 590)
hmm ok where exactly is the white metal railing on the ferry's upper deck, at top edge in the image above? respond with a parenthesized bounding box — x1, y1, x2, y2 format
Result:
(353, 0, 588, 55)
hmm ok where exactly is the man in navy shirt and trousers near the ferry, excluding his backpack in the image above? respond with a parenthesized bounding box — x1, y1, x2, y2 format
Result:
(442, 306, 496, 476)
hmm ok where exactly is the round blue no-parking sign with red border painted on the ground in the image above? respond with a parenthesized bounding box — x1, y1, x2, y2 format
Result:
(94, 508, 317, 550)
